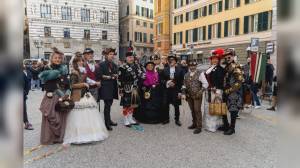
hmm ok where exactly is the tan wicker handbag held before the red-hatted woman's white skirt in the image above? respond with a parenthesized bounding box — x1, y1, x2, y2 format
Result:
(209, 97, 228, 116)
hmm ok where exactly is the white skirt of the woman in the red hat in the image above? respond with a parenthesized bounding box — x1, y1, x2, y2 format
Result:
(201, 91, 222, 132)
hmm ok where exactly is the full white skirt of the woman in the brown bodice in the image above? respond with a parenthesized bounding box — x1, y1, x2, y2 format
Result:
(64, 93, 108, 144)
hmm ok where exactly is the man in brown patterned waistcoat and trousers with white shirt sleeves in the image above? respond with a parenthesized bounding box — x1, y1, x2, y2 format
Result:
(182, 61, 208, 134)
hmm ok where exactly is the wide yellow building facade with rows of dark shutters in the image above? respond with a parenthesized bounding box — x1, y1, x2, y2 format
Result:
(172, 0, 274, 63)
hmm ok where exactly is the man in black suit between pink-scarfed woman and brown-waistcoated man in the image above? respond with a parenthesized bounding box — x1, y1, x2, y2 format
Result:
(162, 55, 184, 126)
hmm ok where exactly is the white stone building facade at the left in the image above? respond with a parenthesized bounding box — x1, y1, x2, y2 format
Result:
(27, 0, 119, 59)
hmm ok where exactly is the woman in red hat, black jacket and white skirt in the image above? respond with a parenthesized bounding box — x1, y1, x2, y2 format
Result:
(203, 49, 225, 132)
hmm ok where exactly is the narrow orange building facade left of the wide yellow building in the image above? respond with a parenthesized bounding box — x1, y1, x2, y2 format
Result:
(154, 0, 172, 56)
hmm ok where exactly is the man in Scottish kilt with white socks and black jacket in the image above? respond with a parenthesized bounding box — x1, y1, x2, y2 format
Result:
(119, 51, 143, 127)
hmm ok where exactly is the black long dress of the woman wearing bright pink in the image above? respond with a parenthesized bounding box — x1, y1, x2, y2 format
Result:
(133, 73, 163, 124)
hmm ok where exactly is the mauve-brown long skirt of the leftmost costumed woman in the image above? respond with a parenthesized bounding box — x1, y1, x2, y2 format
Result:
(40, 95, 68, 145)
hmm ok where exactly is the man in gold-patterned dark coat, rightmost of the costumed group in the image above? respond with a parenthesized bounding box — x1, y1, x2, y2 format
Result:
(219, 49, 244, 135)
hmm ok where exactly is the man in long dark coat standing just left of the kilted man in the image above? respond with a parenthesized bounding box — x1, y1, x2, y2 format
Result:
(97, 48, 118, 131)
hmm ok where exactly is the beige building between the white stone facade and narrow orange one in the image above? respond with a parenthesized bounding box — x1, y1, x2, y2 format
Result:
(119, 0, 154, 59)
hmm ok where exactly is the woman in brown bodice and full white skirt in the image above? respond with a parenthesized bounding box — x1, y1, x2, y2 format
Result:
(64, 57, 108, 144)
